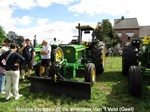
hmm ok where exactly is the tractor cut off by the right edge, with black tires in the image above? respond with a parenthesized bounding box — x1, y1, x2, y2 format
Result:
(122, 35, 150, 97)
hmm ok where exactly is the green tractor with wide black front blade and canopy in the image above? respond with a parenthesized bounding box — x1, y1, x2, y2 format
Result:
(29, 24, 105, 99)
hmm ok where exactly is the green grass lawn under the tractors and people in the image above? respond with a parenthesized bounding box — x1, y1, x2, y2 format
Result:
(0, 57, 150, 112)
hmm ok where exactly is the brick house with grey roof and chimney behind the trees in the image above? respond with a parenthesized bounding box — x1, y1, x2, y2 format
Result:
(114, 16, 150, 47)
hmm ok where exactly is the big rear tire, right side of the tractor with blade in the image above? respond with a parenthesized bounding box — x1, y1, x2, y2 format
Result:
(91, 42, 106, 74)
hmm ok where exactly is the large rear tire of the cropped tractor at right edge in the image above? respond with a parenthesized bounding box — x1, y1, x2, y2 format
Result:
(122, 44, 138, 76)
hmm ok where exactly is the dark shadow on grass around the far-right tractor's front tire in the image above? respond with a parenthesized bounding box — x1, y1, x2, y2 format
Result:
(106, 75, 150, 112)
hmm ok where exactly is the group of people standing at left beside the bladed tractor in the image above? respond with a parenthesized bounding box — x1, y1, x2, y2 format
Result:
(0, 39, 51, 100)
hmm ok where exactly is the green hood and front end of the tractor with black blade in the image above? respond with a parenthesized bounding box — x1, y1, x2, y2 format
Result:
(62, 45, 86, 78)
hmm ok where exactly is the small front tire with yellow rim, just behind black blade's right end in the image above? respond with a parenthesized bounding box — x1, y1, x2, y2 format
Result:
(84, 63, 96, 86)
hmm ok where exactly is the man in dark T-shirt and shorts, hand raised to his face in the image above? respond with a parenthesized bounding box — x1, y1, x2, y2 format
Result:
(19, 39, 35, 80)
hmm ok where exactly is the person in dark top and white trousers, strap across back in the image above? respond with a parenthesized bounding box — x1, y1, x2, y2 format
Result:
(0, 43, 25, 100)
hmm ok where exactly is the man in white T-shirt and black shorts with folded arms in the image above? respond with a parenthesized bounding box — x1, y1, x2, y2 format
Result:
(39, 40, 51, 76)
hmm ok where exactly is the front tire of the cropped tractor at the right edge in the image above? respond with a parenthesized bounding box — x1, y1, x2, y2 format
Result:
(128, 66, 142, 97)
